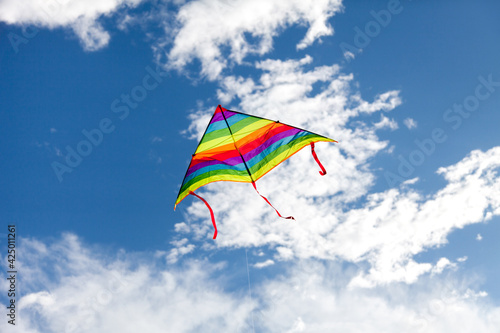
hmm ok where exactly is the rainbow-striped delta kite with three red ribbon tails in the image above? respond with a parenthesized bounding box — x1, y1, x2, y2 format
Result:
(174, 105, 337, 239)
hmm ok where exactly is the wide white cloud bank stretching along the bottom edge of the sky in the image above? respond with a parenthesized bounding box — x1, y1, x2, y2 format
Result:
(0, 234, 500, 333)
